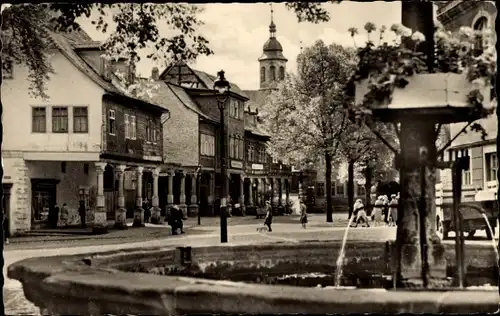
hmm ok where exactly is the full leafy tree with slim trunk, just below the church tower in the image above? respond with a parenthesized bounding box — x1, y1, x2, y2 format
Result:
(262, 41, 355, 222)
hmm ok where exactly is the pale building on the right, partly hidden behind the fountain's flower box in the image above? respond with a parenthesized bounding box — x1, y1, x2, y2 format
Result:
(437, 1, 498, 198)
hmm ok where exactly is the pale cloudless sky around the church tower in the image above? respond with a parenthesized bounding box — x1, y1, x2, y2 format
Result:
(79, 1, 401, 90)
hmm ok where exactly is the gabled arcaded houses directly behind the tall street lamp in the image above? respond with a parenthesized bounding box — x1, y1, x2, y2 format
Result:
(158, 62, 289, 215)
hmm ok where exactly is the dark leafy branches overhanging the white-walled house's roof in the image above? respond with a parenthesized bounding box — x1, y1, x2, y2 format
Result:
(1, 2, 212, 98)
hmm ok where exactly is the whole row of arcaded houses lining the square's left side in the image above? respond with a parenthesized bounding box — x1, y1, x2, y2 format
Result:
(1, 19, 292, 234)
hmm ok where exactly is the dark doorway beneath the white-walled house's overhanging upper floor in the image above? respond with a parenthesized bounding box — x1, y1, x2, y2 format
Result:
(31, 179, 59, 229)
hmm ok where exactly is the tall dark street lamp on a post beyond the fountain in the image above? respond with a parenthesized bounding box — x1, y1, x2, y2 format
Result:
(214, 70, 231, 243)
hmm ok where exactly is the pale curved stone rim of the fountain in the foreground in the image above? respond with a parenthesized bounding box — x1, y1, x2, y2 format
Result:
(7, 241, 498, 313)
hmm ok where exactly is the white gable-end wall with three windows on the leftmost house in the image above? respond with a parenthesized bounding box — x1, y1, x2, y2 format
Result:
(1, 49, 104, 233)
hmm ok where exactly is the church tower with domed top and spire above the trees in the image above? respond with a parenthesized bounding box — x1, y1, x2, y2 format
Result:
(259, 4, 288, 90)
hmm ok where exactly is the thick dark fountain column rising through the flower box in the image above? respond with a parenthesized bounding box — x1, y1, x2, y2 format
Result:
(394, 1, 446, 287)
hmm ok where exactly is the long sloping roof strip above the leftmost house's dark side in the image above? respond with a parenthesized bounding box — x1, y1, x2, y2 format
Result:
(49, 31, 168, 112)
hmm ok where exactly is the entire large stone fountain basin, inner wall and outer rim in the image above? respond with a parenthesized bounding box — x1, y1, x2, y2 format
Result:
(7, 241, 500, 315)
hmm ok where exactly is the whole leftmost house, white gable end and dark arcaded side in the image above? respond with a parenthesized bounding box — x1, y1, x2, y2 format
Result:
(2, 31, 168, 234)
